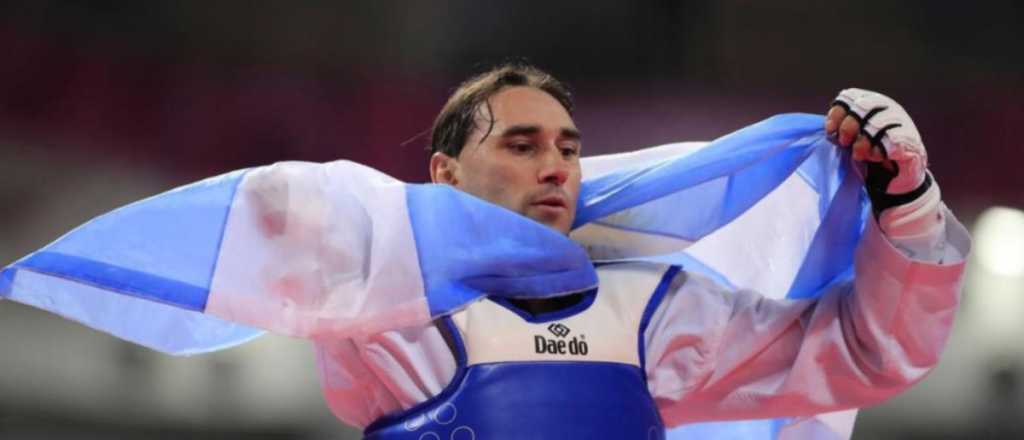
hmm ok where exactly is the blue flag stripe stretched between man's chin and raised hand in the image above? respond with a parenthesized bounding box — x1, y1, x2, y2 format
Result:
(575, 114, 830, 240)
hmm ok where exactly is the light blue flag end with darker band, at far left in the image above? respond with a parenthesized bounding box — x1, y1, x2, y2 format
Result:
(0, 170, 263, 354)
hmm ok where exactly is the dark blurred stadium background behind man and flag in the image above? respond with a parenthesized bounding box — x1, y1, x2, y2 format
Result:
(0, 0, 1024, 439)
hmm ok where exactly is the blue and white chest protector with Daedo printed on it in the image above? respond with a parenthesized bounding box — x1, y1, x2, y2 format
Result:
(365, 263, 678, 440)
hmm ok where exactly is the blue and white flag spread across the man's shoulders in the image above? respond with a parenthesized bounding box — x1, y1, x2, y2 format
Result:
(0, 114, 868, 439)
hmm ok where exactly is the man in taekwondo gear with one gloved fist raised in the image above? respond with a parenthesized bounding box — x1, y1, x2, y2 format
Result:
(307, 65, 966, 439)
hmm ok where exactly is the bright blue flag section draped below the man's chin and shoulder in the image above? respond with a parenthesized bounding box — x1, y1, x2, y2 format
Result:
(406, 185, 597, 316)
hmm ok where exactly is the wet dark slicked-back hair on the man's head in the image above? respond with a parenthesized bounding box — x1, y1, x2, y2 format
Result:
(430, 62, 572, 158)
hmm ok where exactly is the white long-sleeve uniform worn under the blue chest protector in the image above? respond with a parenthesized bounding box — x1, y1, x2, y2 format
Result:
(316, 180, 970, 427)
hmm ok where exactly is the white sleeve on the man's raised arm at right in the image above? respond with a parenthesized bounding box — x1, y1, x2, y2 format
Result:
(645, 189, 970, 426)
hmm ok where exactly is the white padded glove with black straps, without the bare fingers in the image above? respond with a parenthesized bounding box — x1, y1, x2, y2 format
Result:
(834, 89, 928, 194)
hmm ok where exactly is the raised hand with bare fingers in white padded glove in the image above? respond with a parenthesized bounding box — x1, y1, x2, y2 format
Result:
(825, 89, 928, 194)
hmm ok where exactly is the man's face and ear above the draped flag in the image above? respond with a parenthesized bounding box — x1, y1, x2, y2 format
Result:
(430, 87, 581, 233)
